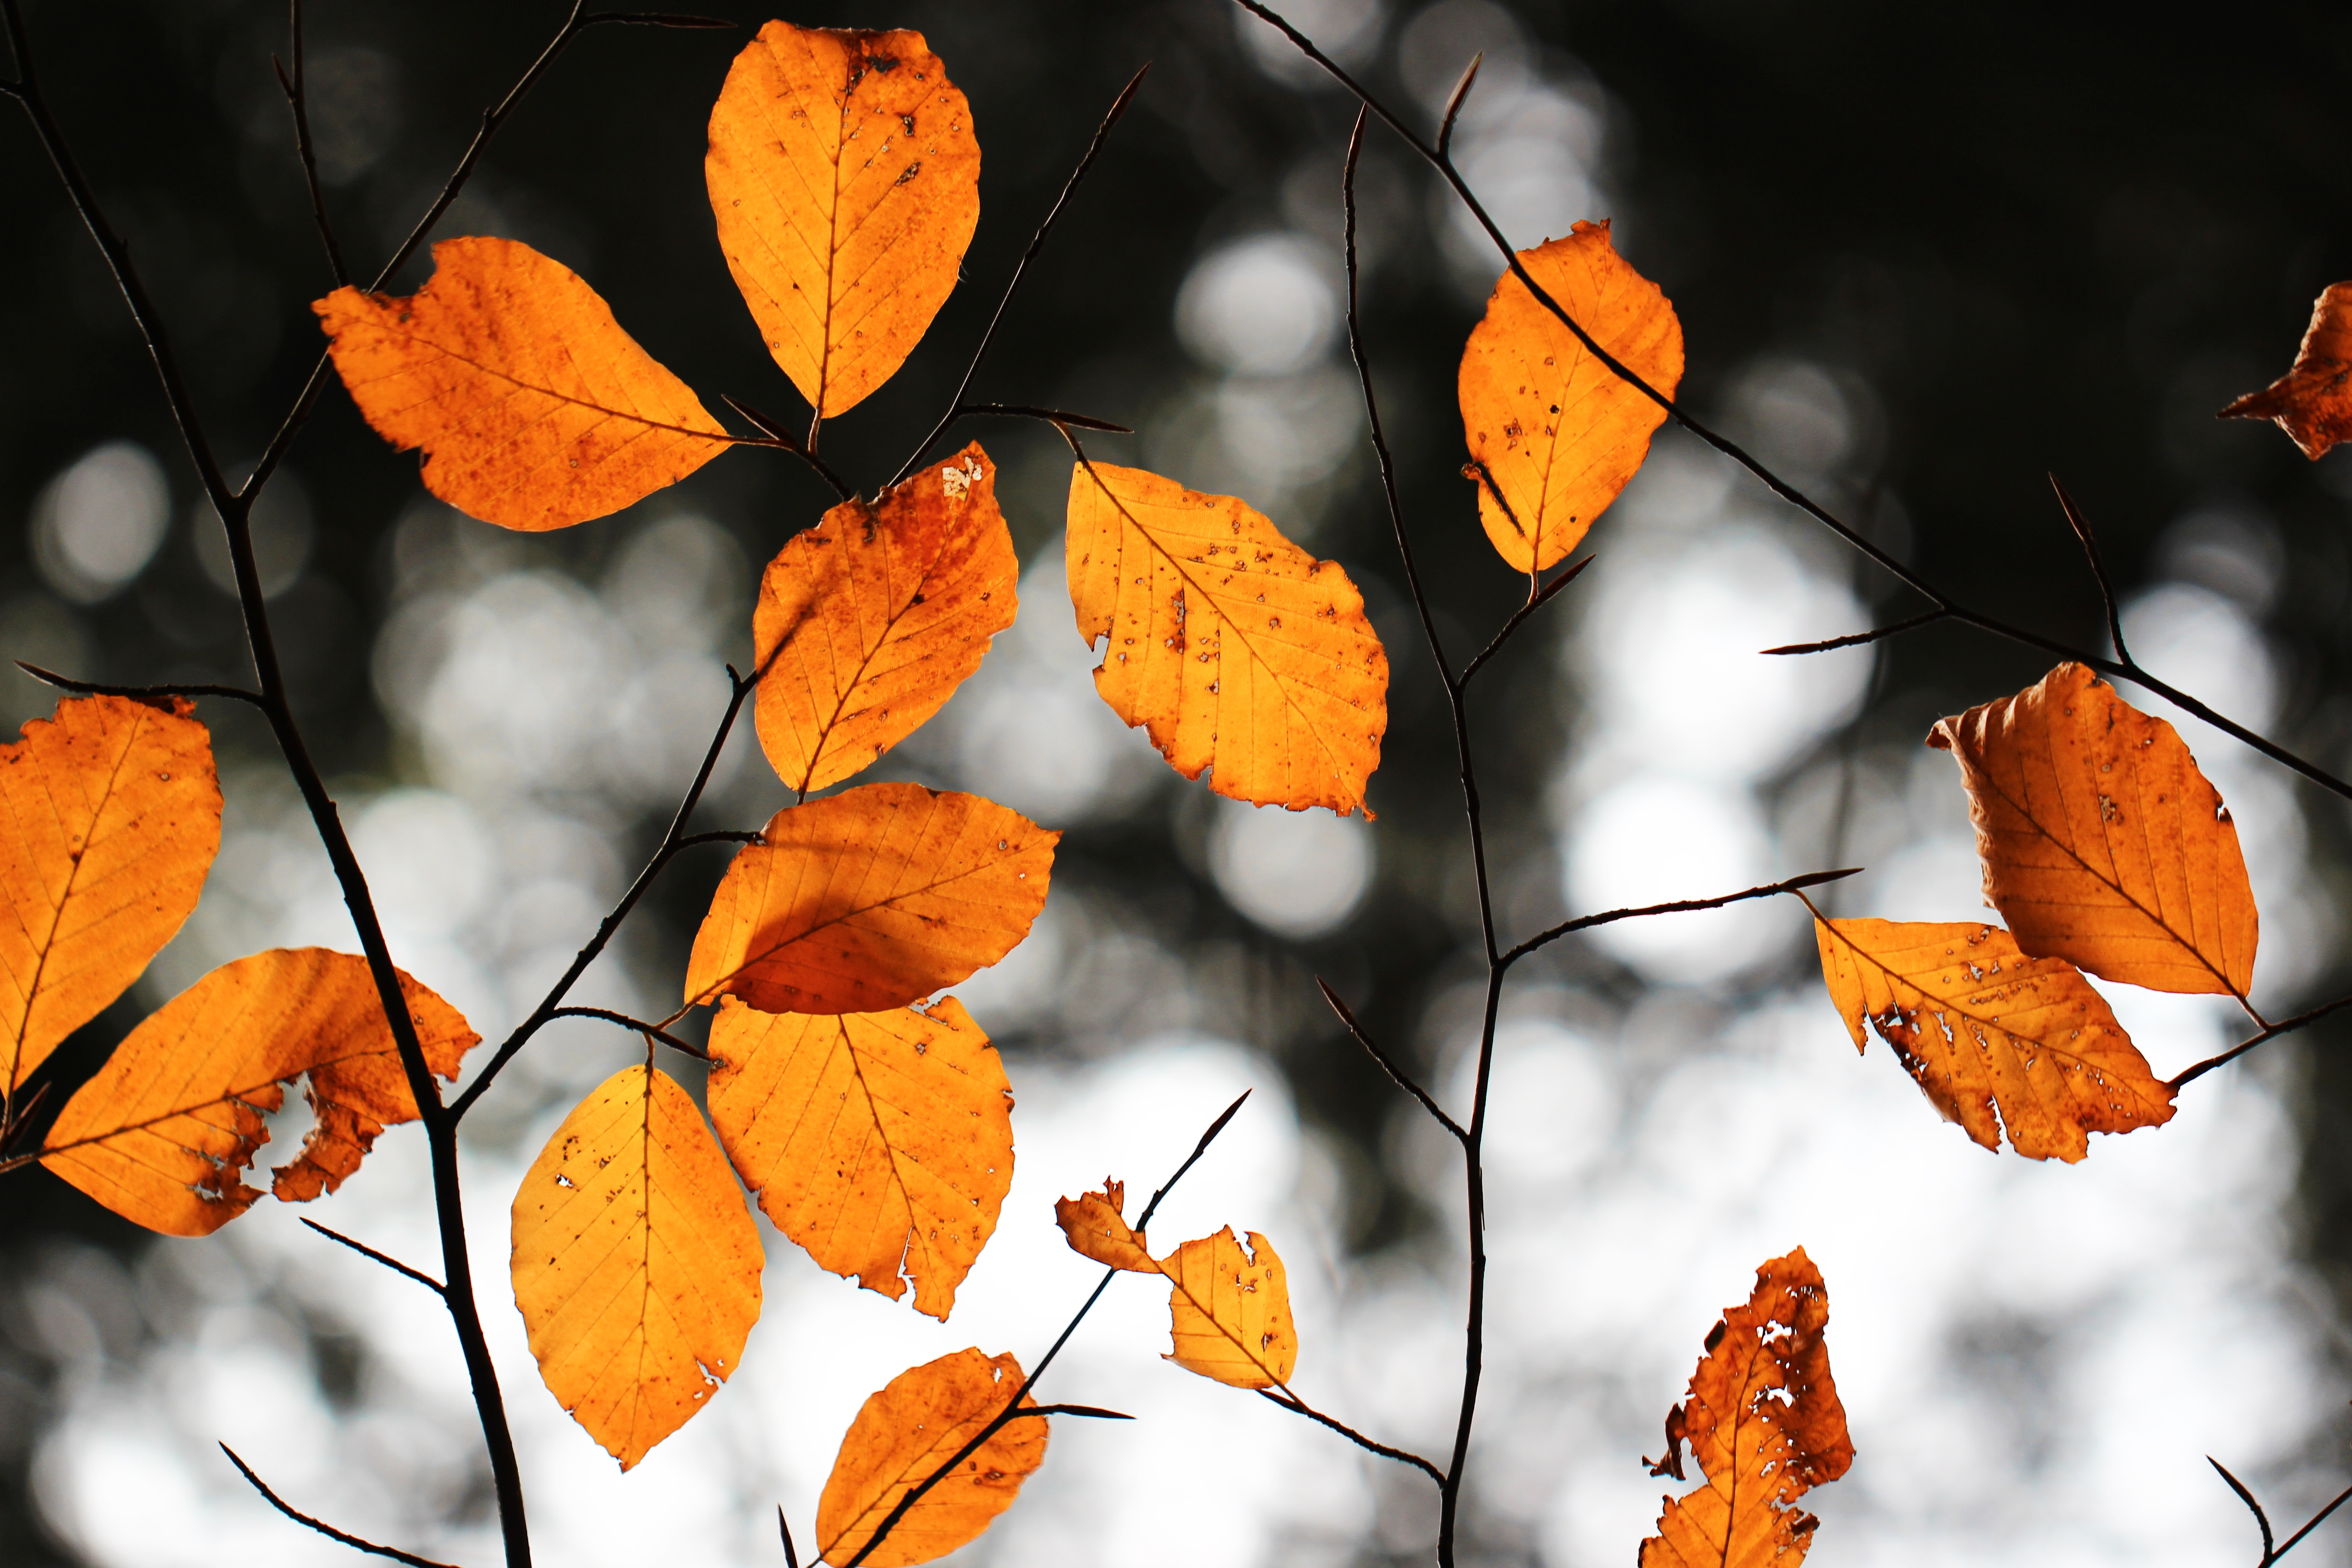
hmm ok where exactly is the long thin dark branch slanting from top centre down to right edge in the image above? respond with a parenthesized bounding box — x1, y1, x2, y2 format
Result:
(1235, 0, 2352, 799)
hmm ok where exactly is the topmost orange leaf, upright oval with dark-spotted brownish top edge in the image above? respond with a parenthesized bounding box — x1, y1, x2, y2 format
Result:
(703, 21, 981, 418)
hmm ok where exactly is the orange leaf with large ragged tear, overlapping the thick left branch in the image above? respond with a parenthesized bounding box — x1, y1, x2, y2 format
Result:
(40, 947, 480, 1236)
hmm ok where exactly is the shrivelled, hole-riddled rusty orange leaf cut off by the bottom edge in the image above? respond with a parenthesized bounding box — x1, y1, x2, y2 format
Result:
(1642, 1246, 1853, 1568)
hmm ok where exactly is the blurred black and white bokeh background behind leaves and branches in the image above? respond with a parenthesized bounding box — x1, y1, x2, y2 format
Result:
(0, 0, 2352, 1568)
